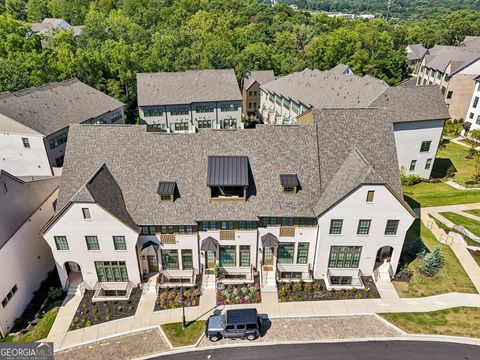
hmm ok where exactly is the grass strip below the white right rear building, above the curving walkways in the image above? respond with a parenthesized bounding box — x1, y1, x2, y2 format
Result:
(403, 182, 480, 208)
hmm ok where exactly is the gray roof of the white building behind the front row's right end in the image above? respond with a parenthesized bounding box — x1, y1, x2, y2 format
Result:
(371, 85, 450, 122)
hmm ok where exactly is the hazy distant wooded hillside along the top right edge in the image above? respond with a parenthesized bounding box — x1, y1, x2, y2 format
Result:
(281, 0, 480, 19)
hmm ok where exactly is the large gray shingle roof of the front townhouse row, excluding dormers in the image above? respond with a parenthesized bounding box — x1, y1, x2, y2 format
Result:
(54, 116, 410, 225)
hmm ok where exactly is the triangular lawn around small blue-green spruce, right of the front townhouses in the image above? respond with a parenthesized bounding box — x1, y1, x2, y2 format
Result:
(393, 220, 476, 297)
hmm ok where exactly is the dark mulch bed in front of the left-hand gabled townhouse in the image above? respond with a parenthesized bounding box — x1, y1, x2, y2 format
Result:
(69, 288, 142, 331)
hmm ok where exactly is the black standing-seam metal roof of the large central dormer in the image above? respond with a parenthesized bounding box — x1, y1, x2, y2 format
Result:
(207, 156, 248, 186)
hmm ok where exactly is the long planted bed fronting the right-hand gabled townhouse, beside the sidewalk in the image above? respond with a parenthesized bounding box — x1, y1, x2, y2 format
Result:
(277, 276, 380, 302)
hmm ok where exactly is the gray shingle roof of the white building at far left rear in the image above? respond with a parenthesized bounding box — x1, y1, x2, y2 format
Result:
(0, 79, 123, 135)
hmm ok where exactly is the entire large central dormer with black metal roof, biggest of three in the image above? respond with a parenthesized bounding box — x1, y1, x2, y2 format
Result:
(207, 156, 248, 201)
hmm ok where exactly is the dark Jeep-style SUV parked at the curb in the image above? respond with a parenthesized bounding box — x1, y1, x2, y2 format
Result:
(205, 309, 263, 342)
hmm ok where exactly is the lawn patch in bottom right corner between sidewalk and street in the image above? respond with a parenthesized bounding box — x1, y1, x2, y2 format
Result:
(379, 307, 480, 338)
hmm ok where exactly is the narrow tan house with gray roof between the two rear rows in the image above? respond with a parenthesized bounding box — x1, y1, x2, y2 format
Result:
(241, 70, 275, 119)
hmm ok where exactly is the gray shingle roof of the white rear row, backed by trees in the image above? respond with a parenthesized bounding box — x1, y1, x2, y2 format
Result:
(137, 69, 242, 106)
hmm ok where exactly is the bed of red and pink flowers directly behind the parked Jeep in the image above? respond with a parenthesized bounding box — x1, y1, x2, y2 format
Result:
(216, 281, 262, 305)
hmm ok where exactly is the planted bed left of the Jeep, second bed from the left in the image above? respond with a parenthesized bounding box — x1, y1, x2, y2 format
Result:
(154, 286, 202, 311)
